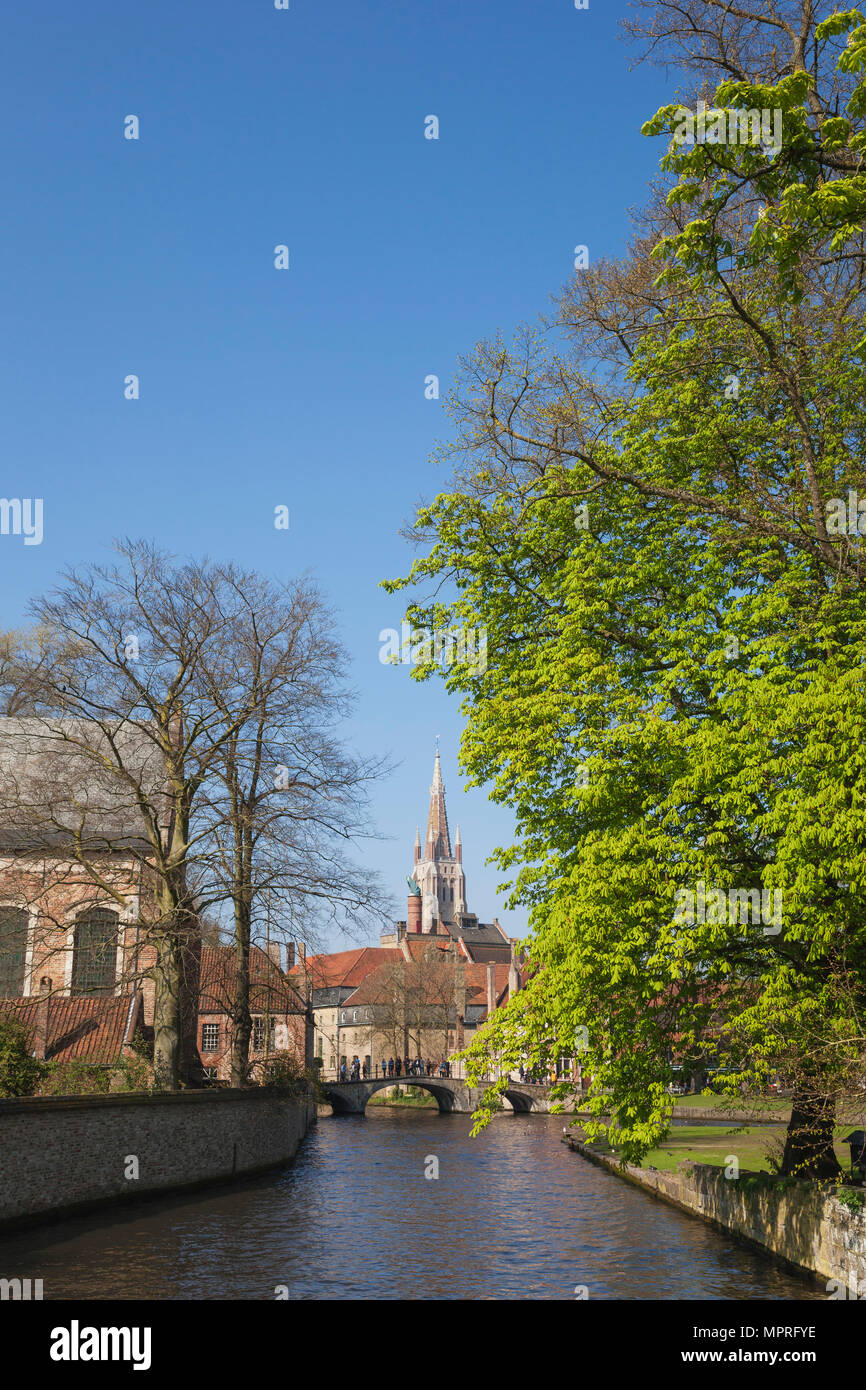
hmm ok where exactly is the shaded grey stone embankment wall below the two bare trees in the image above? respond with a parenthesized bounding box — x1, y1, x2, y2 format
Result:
(0, 1087, 316, 1226)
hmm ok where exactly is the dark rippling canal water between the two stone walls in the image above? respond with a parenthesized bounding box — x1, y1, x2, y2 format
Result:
(0, 1108, 826, 1300)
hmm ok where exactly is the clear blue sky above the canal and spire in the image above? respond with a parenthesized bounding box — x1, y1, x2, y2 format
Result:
(0, 0, 670, 934)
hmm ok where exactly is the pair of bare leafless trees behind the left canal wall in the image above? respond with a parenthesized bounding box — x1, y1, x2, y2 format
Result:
(3, 542, 386, 1088)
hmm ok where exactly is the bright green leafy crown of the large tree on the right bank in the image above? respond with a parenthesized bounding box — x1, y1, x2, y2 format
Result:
(385, 11, 866, 1162)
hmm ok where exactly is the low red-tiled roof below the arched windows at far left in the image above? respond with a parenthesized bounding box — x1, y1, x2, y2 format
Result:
(0, 992, 142, 1063)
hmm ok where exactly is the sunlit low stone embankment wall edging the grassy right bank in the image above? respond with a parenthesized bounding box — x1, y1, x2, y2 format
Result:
(569, 1137, 866, 1297)
